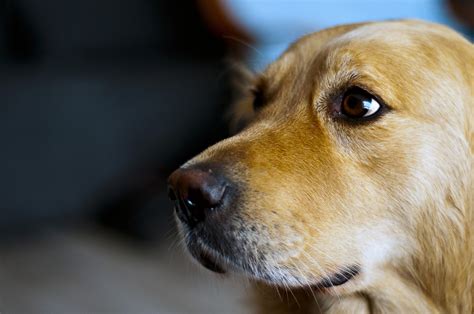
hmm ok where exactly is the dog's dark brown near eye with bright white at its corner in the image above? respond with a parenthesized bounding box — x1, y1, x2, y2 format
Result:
(341, 88, 381, 119)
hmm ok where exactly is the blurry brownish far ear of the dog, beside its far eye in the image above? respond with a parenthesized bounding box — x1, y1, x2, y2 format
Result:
(227, 60, 256, 134)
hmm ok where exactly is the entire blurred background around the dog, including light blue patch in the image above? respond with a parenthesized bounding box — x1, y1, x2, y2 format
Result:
(0, 0, 474, 313)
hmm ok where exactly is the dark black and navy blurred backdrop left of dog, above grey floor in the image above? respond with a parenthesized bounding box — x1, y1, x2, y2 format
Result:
(0, 0, 233, 239)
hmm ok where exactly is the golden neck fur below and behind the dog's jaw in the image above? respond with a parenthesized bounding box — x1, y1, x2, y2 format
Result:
(366, 162, 474, 313)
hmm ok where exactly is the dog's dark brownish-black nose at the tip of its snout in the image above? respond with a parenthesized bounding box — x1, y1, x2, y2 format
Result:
(168, 168, 227, 226)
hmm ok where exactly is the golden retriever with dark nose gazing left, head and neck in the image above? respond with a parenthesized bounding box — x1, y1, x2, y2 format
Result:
(169, 20, 474, 313)
